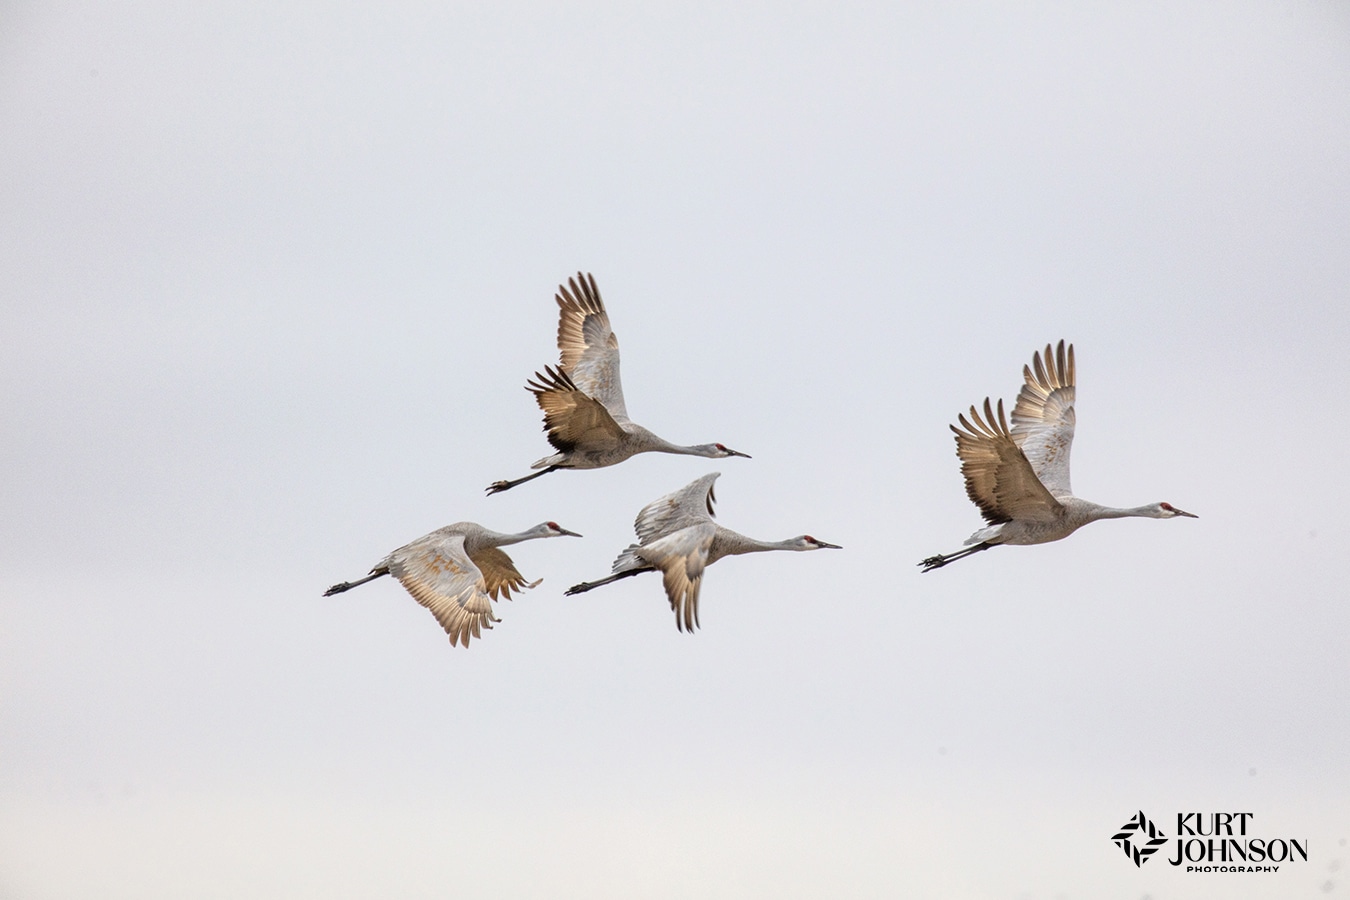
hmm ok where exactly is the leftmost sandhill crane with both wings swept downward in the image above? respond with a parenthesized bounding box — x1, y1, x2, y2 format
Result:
(324, 522, 581, 648)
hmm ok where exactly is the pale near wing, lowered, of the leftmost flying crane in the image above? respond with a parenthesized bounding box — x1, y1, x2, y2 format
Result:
(382, 532, 499, 646)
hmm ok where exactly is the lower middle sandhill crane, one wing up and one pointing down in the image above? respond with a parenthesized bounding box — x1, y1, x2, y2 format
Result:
(566, 472, 842, 634)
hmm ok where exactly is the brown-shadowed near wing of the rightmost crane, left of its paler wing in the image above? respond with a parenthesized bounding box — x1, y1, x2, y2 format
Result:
(952, 398, 1064, 525)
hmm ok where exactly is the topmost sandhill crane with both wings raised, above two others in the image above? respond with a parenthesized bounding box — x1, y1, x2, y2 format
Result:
(487, 273, 749, 494)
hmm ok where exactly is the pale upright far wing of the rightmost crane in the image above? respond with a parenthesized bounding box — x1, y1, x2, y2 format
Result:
(1013, 340, 1076, 497)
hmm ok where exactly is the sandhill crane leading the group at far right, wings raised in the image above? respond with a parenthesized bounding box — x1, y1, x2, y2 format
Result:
(919, 340, 1200, 572)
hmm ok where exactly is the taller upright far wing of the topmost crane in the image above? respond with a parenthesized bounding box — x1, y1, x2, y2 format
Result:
(555, 273, 629, 422)
